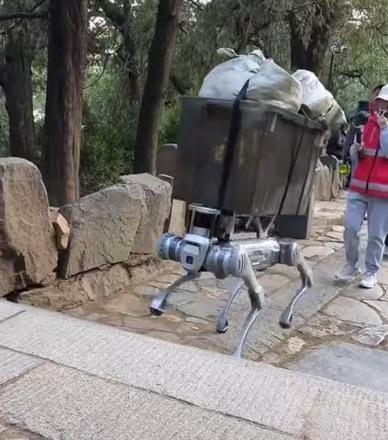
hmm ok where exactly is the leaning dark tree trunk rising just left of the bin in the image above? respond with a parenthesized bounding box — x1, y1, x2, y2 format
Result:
(135, 0, 183, 174)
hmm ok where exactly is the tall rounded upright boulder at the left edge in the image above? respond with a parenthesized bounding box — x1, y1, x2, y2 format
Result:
(0, 158, 58, 296)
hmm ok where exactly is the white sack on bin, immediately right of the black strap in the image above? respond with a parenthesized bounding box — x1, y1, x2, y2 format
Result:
(247, 60, 302, 112)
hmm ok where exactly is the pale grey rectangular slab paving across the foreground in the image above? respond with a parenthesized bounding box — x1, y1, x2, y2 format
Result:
(0, 301, 388, 440)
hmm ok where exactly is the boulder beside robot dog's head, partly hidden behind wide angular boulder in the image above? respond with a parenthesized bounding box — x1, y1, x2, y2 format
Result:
(121, 174, 172, 254)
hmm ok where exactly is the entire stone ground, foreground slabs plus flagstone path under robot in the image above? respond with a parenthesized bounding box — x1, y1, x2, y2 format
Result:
(0, 199, 388, 440)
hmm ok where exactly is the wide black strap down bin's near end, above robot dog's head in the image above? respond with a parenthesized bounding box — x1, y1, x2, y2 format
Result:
(218, 80, 249, 208)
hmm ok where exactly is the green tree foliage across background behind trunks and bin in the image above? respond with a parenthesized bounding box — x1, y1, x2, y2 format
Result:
(0, 0, 388, 193)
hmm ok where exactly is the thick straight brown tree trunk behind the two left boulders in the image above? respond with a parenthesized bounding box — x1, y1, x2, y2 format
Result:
(43, 0, 87, 206)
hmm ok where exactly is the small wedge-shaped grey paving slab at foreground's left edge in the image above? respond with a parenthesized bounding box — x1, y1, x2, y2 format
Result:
(0, 348, 43, 385)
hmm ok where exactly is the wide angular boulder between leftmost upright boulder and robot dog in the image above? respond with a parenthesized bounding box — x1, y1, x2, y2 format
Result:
(59, 183, 143, 278)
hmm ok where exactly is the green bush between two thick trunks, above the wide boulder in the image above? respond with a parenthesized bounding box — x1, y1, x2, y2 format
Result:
(80, 69, 137, 194)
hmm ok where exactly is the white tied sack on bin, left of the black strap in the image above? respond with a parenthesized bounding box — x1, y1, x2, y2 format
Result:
(198, 49, 265, 100)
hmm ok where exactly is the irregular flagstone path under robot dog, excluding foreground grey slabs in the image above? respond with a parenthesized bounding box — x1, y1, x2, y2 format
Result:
(11, 192, 388, 391)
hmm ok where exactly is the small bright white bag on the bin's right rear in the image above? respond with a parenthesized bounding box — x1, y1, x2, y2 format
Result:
(293, 70, 334, 119)
